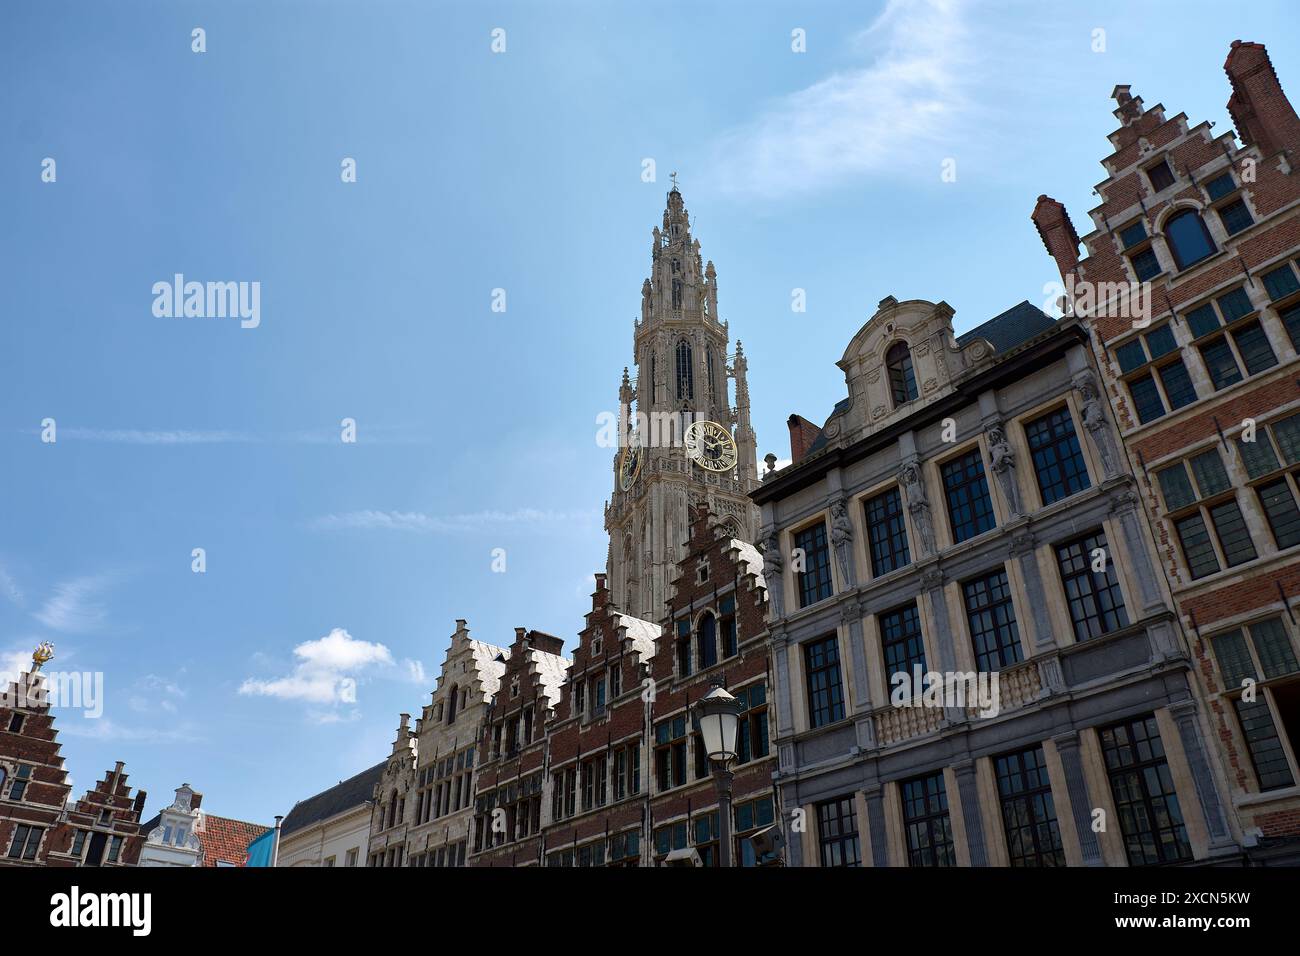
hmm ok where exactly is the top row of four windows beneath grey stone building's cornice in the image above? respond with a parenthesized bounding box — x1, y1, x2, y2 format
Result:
(794, 406, 1091, 607)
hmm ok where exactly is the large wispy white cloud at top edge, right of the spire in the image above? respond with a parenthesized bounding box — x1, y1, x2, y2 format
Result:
(714, 0, 969, 198)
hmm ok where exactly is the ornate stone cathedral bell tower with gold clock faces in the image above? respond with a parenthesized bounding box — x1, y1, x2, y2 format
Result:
(605, 182, 758, 622)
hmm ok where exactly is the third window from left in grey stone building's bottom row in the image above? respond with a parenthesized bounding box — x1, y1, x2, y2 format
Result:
(993, 745, 1065, 866)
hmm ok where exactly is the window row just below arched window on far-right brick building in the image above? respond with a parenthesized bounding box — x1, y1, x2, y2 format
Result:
(1114, 263, 1300, 424)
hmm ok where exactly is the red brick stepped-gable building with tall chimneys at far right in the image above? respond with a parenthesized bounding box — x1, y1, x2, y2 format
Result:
(1032, 42, 1300, 847)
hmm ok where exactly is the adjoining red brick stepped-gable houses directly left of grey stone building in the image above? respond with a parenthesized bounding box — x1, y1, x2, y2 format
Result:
(469, 506, 776, 866)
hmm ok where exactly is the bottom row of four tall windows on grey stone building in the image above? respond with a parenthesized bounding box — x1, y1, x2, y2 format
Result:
(816, 714, 1192, 866)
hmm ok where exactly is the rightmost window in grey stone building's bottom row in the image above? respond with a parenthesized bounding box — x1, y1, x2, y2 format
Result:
(1099, 714, 1192, 866)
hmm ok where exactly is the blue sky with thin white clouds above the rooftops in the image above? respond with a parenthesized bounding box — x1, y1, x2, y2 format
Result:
(0, 1, 1300, 823)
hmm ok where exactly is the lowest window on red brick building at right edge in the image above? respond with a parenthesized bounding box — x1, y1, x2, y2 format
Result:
(1209, 618, 1300, 791)
